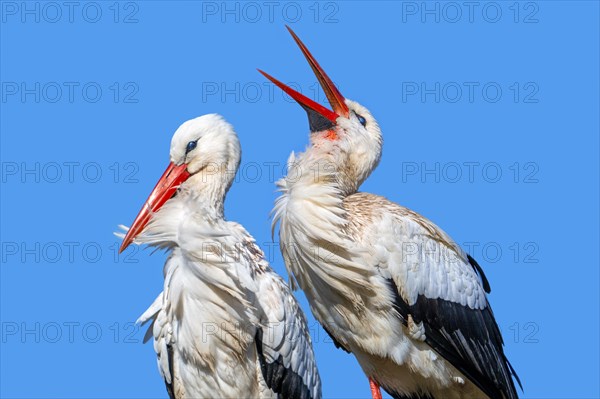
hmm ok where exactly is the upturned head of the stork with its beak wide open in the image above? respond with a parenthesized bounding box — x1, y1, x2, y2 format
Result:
(259, 27, 383, 192)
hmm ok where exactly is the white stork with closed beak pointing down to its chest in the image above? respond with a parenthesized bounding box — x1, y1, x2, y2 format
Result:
(121, 114, 321, 399)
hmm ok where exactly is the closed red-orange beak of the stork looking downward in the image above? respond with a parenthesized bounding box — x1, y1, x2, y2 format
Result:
(119, 162, 190, 253)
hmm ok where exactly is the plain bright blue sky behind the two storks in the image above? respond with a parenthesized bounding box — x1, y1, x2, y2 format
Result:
(0, 1, 600, 398)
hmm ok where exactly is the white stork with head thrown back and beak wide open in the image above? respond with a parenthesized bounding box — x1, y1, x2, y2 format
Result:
(260, 28, 520, 399)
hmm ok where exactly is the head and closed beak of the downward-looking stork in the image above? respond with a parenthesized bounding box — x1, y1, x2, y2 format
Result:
(119, 114, 241, 252)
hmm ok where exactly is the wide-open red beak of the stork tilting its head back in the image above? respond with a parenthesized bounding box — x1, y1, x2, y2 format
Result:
(258, 26, 349, 132)
